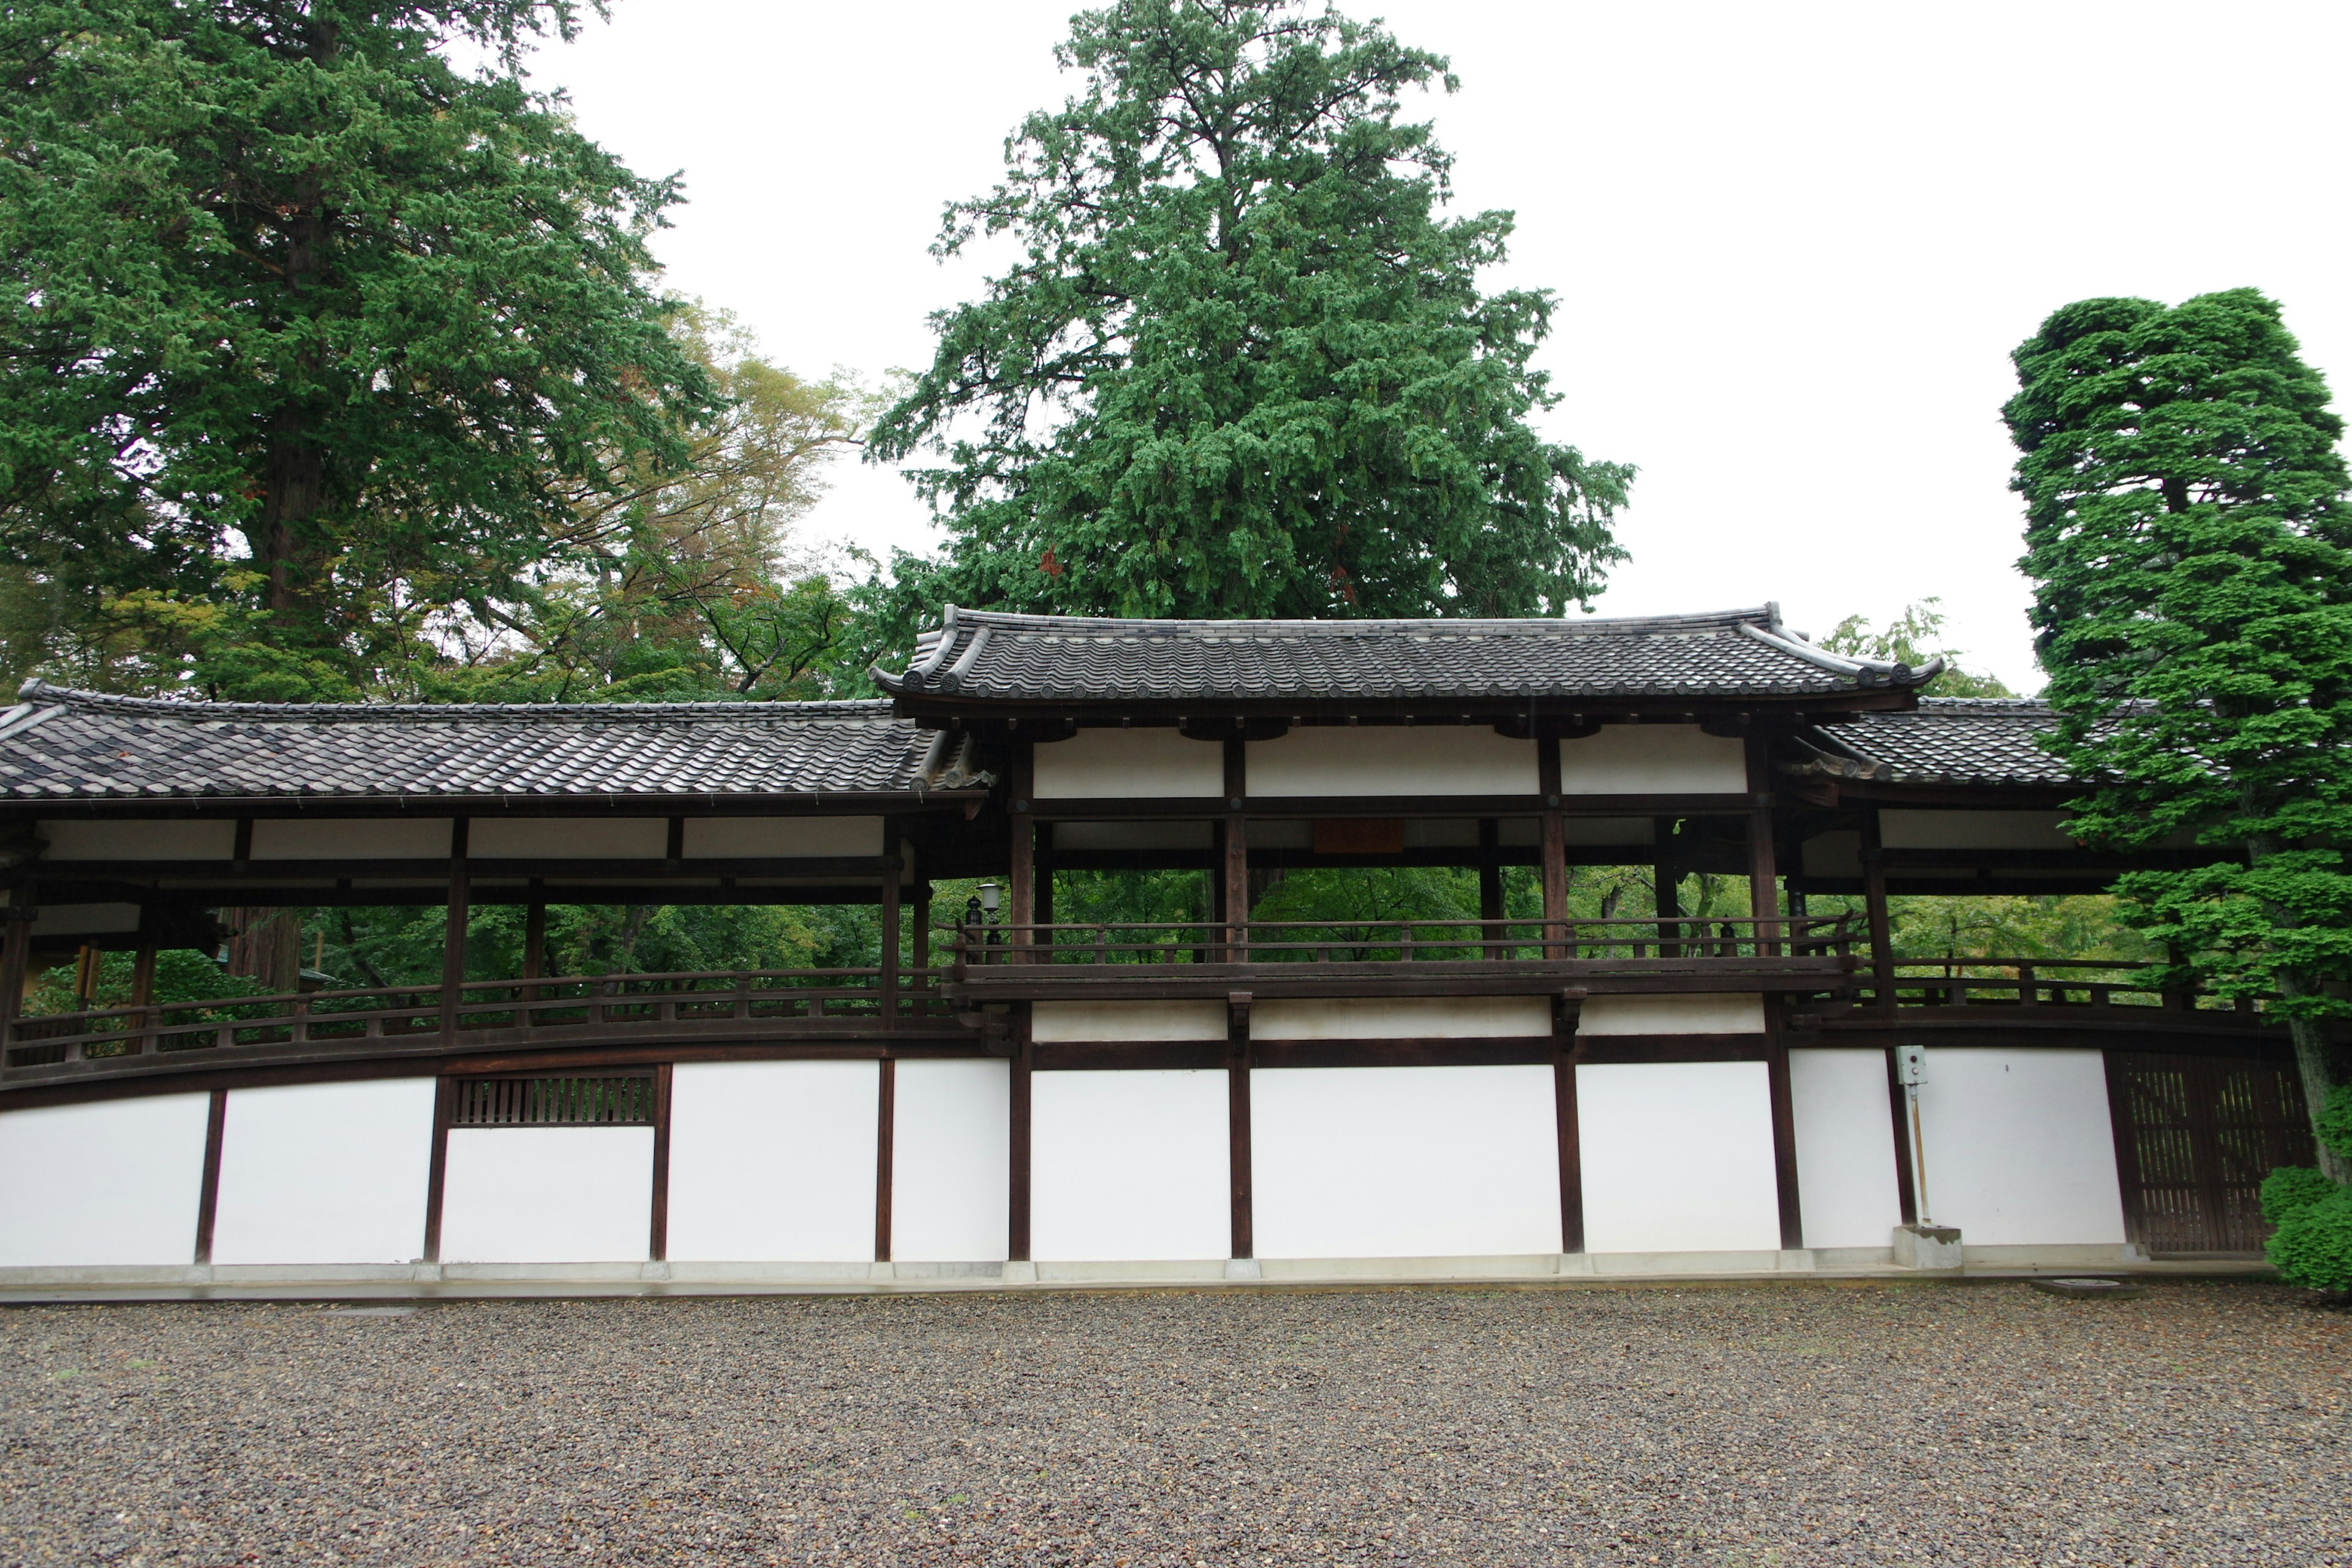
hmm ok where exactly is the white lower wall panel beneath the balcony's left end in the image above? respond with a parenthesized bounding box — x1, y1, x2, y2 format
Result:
(1030, 1069, 1232, 1262)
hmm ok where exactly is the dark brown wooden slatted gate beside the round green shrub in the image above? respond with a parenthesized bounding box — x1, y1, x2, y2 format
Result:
(2108, 1051, 2316, 1253)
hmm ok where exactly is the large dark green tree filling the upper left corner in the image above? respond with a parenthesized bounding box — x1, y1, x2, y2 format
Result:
(0, 0, 713, 696)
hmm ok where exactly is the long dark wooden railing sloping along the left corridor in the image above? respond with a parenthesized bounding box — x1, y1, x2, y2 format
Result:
(5, 968, 952, 1069)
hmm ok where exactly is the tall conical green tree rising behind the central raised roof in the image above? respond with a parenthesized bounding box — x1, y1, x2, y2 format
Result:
(870, 0, 1632, 635)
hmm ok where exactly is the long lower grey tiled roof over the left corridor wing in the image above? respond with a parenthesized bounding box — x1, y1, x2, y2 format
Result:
(0, 682, 971, 802)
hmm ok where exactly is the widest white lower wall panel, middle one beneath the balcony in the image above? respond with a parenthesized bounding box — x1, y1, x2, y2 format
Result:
(1249, 1067, 1559, 1257)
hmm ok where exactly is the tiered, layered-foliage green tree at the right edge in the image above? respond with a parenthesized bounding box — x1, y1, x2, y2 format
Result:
(2007, 289, 2352, 1180)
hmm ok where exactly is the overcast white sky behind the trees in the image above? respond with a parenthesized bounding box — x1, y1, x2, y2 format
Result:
(532, 0, 2352, 689)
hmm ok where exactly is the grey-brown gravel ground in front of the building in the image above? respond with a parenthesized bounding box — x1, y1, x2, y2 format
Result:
(0, 1284, 2352, 1568)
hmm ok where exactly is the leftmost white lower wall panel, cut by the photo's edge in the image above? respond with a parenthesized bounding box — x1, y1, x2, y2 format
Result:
(0, 1093, 212, 1267)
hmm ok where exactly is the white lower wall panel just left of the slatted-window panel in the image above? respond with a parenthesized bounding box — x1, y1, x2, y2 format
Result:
(212, 1077, 433, 1262)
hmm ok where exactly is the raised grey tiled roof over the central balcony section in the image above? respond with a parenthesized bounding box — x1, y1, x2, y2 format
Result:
(875, 604, 1943, 705)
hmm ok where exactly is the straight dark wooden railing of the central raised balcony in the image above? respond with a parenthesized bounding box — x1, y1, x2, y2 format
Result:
(943, 914, 1856, 978)
